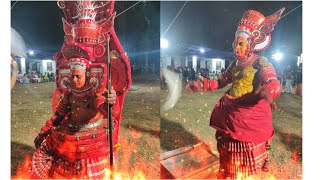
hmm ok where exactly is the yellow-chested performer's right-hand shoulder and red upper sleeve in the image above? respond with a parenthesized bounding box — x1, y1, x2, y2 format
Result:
(254, 57, 282, 103)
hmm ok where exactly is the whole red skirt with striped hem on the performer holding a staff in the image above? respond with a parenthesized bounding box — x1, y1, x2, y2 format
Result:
(30, 129, 110, 179)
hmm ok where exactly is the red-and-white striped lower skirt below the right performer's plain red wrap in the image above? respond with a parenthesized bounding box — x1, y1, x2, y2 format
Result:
(217, 133, 268, 179)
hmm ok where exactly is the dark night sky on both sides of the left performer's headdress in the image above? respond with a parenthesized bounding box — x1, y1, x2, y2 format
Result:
(11, 1, 160, 63)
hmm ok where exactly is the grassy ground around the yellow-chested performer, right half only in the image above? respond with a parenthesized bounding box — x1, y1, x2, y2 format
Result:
(160, 87, 302, 179)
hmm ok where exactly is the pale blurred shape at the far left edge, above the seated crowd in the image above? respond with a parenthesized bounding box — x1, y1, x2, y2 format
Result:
(11, 28, 27, 58)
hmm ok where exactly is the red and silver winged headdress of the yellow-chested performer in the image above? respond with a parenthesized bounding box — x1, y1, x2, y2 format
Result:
(235, 8, 285, 52)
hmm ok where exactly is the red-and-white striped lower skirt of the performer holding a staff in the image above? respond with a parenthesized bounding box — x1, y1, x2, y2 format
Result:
(29, 143, 109, 179)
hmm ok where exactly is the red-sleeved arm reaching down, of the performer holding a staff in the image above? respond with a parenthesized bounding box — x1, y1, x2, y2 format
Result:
(34, 93, 71, 148)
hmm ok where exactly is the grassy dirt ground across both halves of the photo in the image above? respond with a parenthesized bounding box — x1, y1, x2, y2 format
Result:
(11, 76, 303, 179)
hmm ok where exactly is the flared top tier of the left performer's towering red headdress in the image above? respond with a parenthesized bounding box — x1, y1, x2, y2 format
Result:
(58, 0, 115, 47)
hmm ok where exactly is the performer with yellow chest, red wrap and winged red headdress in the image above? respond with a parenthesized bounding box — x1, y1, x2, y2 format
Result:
(210, 8, 284, 178)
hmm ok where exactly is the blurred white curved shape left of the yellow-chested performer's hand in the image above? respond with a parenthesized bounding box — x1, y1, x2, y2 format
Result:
(161, 69, 182, 111)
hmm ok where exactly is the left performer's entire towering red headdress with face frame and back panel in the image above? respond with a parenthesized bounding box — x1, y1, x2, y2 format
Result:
(52, 0, 131, 156)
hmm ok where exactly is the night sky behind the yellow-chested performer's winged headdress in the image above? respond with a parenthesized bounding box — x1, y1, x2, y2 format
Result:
(160, 1, 303, 59)
